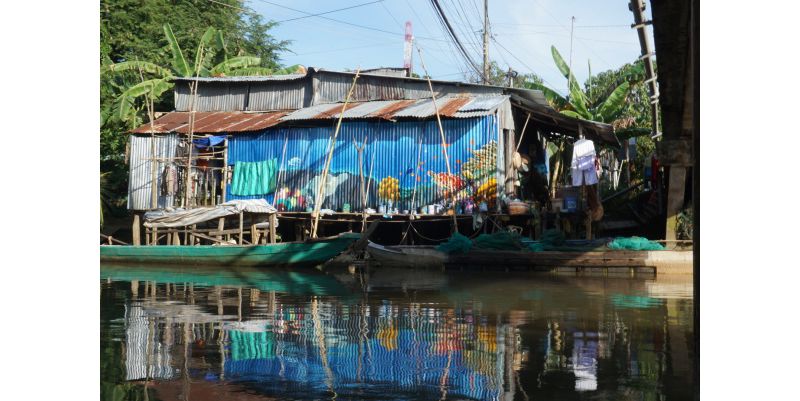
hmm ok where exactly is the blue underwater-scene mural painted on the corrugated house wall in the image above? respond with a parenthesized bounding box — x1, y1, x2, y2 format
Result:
(228, 116, 502, 211)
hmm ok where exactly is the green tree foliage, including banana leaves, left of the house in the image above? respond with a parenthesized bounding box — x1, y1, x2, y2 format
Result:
(100, 0, 290, 217)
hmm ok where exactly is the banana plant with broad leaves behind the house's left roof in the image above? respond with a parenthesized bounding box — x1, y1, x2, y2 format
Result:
(101, 24, 299, 125)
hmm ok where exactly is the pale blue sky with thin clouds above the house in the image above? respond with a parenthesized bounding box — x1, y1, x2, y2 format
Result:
(245, 0, 653, 94)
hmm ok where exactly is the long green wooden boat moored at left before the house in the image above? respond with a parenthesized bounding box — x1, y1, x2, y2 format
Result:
(100, 233, 361, 267)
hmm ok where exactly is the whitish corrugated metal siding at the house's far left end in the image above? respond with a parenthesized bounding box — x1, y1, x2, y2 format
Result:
(128, 134, 178, 210)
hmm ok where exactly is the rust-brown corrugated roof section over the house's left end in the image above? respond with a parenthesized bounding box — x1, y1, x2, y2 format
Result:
(131, 111, 288, 134)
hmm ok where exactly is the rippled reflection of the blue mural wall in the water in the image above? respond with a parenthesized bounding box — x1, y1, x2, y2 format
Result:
(225, 301, 520, 399)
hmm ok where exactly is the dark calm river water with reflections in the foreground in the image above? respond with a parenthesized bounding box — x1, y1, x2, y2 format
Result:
(100, 265, 696, 401)
